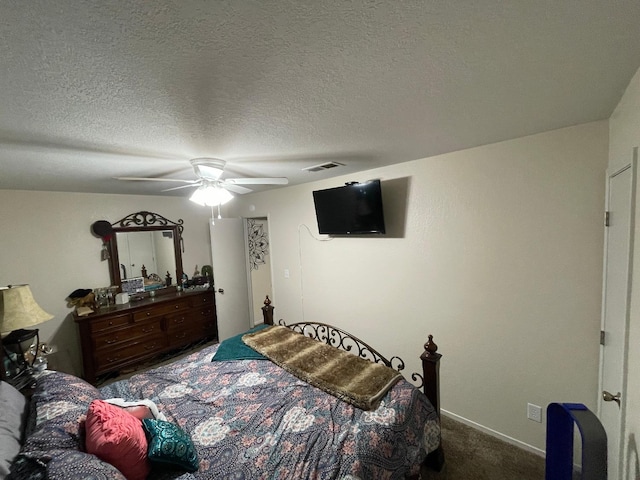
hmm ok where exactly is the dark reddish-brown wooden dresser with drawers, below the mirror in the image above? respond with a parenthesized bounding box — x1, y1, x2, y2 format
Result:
(74, 290, 218, 383)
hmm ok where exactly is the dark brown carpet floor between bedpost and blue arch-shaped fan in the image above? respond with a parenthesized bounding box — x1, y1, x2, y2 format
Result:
(421, 416, 544, 480)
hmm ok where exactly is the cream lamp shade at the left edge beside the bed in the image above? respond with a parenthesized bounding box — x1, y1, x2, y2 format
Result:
(0, 285, 53, 332)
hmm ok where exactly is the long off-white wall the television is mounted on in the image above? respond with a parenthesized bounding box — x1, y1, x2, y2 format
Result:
(227, 121, 608, 450)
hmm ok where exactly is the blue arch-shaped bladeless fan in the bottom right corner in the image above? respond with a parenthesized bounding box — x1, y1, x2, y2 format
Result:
(545, 403, 607, 480)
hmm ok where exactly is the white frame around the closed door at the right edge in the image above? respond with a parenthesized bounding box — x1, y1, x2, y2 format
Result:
(596, 147, 638, 475)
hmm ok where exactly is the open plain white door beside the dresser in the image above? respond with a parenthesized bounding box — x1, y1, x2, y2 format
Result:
(209, 218, 250, 341)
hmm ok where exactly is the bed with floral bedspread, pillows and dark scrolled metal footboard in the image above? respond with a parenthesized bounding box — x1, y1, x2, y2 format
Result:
(0, 310, 443, 480)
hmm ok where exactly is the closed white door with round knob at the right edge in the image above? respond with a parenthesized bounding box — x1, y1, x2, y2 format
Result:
(598, 149, 637, 480)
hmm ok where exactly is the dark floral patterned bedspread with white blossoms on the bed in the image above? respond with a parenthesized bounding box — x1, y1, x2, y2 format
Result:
(15, 345, 440, 480)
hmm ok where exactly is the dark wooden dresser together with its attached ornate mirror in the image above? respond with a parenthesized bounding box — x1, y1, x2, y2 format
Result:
(74, 211, 218, 383)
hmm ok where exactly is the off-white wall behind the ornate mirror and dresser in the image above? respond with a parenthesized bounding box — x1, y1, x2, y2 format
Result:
(0, 190, 211, 374)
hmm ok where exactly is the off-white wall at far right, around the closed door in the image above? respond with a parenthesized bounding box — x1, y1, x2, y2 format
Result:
(609, 66, 640, 480)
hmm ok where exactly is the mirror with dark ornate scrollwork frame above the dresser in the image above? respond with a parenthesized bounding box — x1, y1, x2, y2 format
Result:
(108, 211, 184, 288)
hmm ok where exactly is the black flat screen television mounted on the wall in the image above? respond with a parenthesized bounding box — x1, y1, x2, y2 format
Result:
(313, 180, 385, 235)
